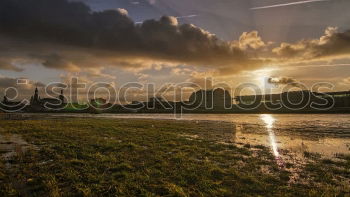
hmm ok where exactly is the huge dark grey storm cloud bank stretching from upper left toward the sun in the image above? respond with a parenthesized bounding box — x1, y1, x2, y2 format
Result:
(0, 0, 260, 72)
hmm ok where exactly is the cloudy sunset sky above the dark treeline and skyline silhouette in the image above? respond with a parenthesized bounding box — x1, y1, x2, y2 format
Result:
(0, 0, 350, 100)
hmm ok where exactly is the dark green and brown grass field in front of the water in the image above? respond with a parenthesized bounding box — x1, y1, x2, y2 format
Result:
(0, 118, 350, 196)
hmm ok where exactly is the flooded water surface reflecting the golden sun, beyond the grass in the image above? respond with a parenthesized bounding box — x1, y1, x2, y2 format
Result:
(34, 114, 350, 157)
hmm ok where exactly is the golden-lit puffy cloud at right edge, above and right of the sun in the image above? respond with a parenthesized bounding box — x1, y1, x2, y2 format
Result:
(273, 27, 350, 60)
